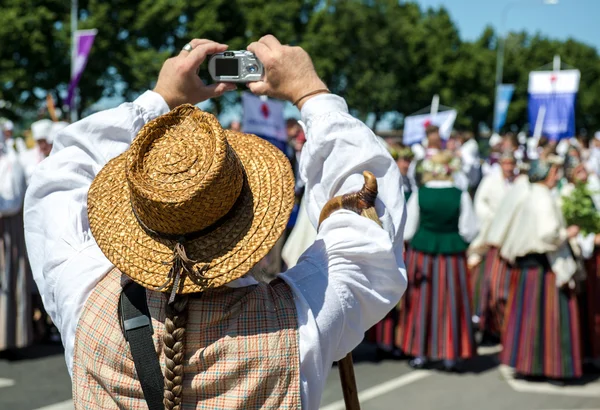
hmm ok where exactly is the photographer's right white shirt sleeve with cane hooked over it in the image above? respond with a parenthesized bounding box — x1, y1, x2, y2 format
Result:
(282, 95, 406, 409)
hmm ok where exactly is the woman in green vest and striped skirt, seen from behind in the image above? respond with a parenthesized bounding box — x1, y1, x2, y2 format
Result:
(397, 151, 478, 370)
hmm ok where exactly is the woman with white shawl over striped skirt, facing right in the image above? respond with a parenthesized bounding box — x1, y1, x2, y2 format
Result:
(495, 155, 582, 379)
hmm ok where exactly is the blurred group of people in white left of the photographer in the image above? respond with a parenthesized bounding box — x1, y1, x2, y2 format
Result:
(0, 119, 68, 351)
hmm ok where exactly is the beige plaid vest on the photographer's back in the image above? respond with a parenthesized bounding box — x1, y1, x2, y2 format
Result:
(73, 269, 301, 410)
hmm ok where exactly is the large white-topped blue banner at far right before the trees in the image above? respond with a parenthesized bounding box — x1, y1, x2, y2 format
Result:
(529, 70, 581, 141)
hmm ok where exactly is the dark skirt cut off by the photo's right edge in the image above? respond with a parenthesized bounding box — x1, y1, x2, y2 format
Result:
(579, 248, 600, 360)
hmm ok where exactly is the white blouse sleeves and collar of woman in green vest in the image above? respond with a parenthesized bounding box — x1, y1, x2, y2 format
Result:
(404, 181, 479, 242)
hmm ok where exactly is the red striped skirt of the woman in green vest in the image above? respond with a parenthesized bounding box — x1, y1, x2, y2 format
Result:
(396, 250, 475, 360)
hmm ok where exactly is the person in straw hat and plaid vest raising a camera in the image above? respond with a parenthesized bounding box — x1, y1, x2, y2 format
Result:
(25, 36, 406, 409)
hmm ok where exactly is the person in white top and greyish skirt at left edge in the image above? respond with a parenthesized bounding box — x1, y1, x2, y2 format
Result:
(0, 123, 33, 351)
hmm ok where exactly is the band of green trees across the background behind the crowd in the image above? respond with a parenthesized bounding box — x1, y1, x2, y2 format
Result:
(0, 0, 600, 130)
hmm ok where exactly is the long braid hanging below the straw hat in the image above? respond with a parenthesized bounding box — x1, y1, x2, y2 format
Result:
(163, 295, 188, 410)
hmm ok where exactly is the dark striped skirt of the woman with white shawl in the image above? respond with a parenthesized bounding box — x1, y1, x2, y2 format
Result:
(500, 266, 582, 379)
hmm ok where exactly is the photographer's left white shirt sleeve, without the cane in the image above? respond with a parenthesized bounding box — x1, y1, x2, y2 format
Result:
(24, 91, 169, 371)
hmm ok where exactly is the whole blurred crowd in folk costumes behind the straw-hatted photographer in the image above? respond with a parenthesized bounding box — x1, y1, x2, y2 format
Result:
(0, 110, 600, 380)
